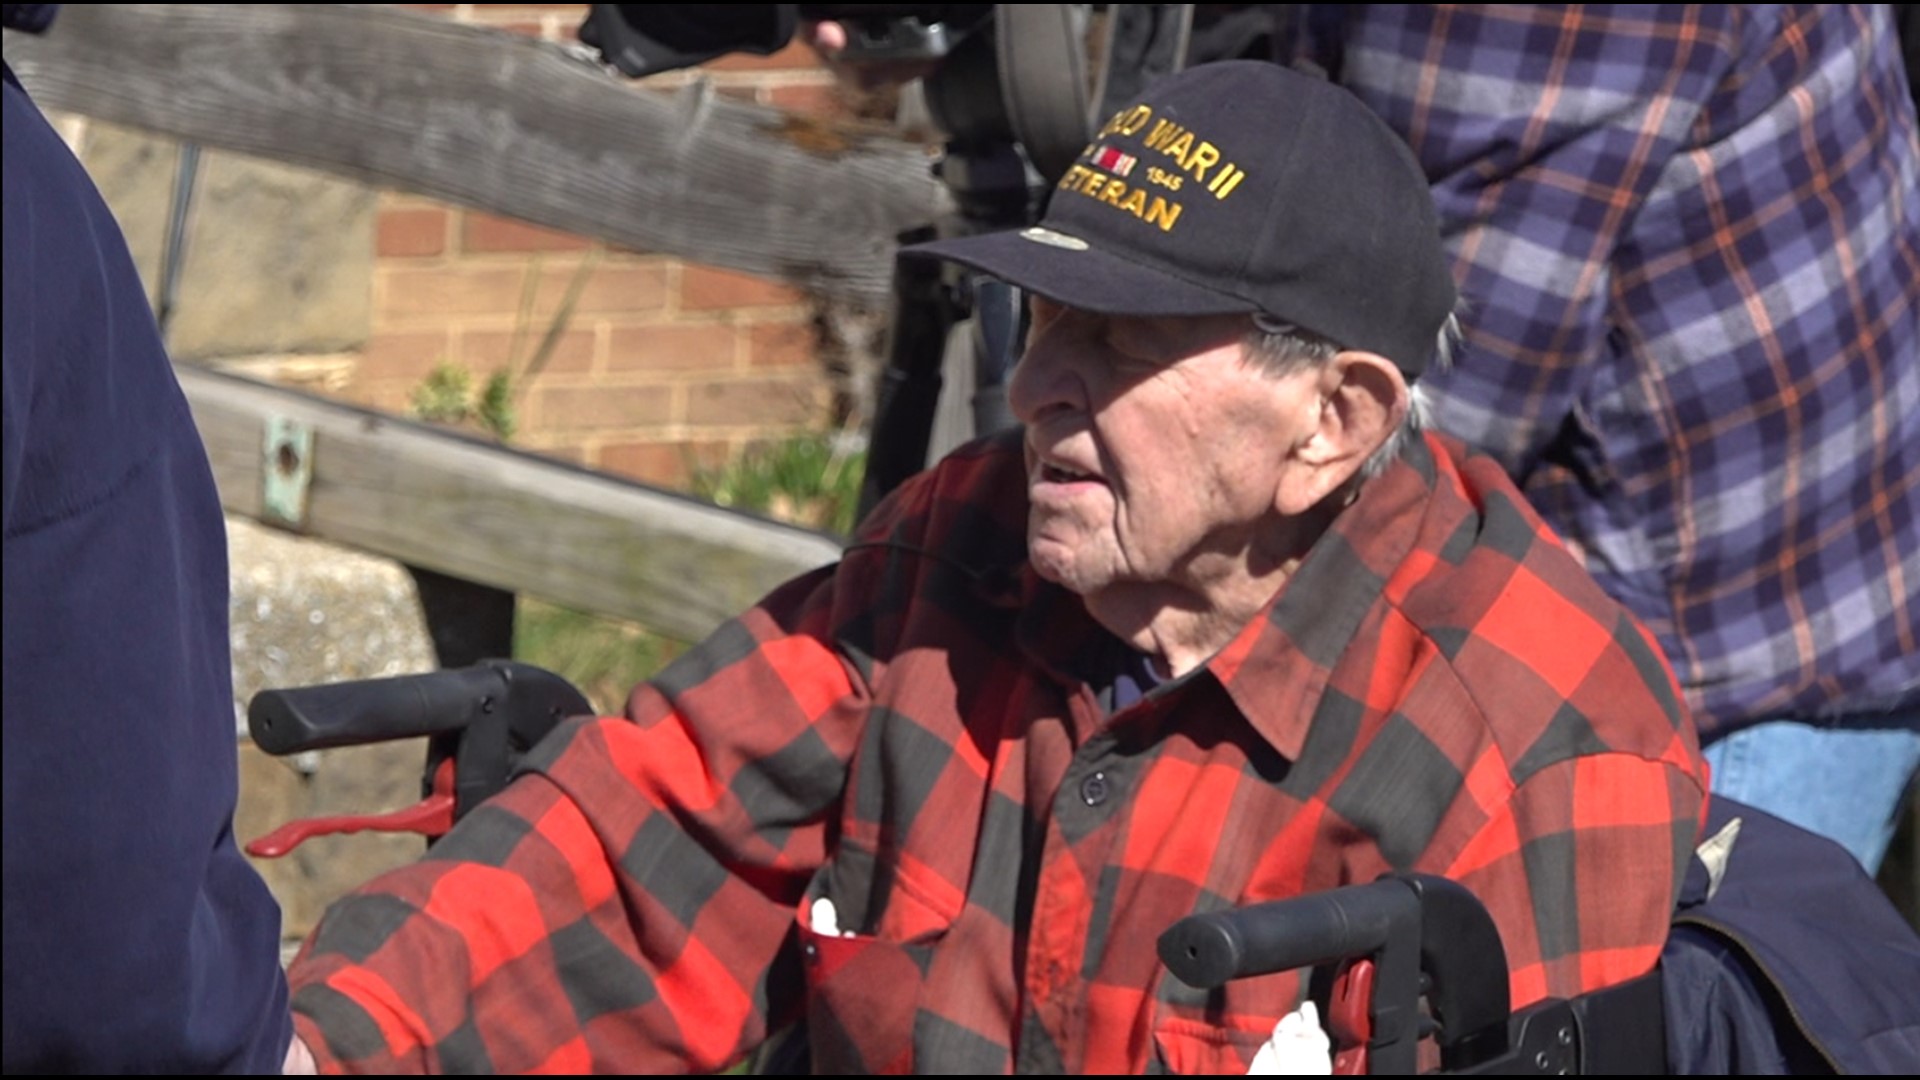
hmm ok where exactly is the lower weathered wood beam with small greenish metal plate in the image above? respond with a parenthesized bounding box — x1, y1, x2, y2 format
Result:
(177, 365, 841, 640)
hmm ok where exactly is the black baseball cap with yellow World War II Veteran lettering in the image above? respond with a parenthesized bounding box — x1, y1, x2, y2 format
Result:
(900, 60, 1455, 379)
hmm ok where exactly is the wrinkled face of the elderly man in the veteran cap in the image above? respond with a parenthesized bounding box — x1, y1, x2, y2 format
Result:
(1008, 298, 1321, 598)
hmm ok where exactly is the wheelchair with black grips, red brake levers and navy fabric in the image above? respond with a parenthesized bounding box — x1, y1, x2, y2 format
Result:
(248, 661, 1920, 1076)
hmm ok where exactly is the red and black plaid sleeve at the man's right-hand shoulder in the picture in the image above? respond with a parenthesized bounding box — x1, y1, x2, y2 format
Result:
(1396, 436, 1707, 1007)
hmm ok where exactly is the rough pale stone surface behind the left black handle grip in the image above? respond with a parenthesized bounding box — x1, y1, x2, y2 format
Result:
(227, 517, 436, 940)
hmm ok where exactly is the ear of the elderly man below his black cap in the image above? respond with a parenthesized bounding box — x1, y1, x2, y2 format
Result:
(1275, 350, 1411, 515)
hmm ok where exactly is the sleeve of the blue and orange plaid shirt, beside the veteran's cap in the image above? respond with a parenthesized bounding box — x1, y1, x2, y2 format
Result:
(1342, 4, 1736, 480)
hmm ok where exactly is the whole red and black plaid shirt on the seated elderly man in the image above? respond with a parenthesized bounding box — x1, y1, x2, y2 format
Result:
(292, 428, 1705, 1072)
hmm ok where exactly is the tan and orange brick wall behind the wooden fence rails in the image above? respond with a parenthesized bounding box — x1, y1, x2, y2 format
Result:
(346, 4, 851, 486)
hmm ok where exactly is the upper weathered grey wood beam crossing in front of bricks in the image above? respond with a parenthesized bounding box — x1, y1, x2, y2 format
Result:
(6, 4, 950, 304)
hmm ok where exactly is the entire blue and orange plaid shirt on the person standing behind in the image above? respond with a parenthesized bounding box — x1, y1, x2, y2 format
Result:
(1302, 4, 1920, 738)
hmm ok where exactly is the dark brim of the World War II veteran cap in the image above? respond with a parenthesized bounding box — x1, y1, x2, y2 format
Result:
(900, 229, 1260, 315)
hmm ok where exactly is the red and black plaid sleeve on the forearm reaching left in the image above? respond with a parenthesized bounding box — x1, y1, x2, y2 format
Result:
(290, 569, 866, 1072)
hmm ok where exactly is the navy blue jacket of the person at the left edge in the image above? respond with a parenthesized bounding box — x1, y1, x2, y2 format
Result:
(0, 42, 292, 1072)
